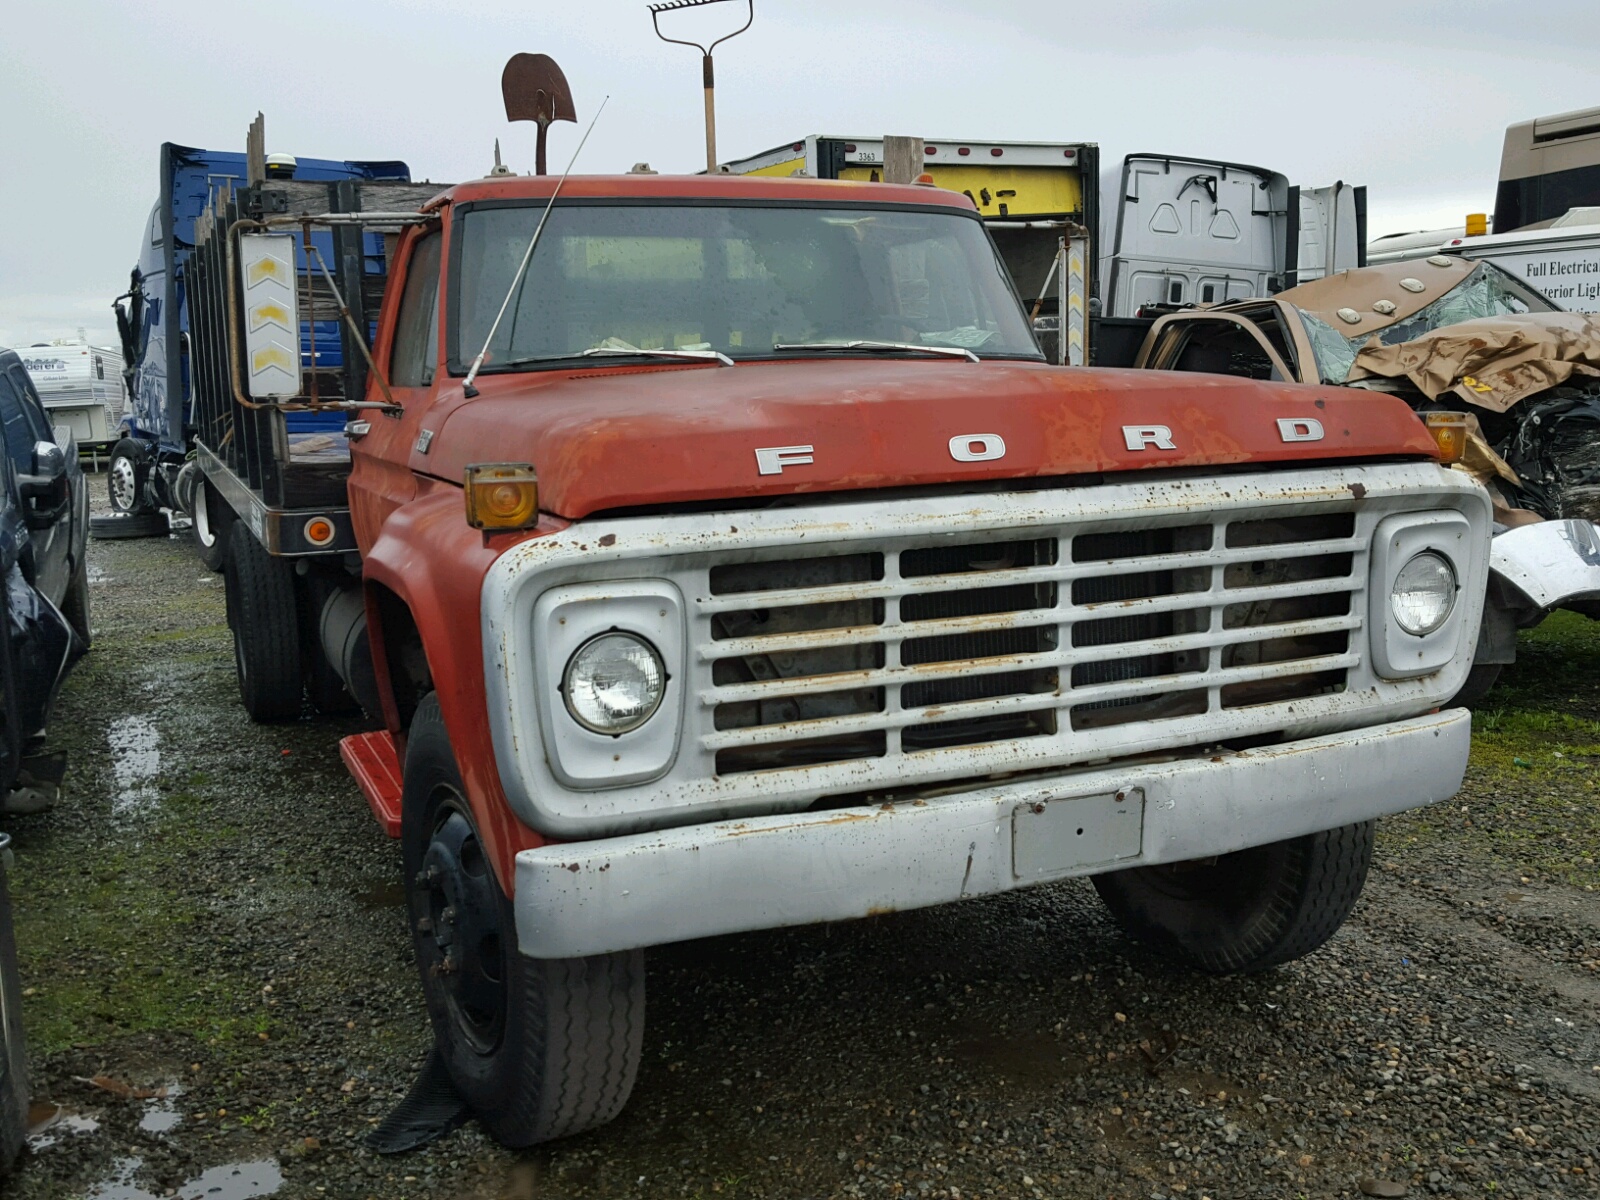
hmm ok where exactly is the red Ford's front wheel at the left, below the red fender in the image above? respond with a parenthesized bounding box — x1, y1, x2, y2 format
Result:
(400, 696, 645, 1147)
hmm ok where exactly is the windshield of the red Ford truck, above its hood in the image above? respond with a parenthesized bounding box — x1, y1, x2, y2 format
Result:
(451, 203, 1040, 371)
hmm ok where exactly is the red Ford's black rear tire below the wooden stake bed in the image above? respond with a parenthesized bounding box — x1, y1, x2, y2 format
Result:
(222, 522, 301, 723)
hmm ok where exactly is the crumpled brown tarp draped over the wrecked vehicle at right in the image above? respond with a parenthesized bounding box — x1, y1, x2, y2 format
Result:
(1349, 312, 1600, 413)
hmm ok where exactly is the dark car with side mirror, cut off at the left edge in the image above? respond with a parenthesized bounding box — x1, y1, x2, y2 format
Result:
(0, 350, 90, 813)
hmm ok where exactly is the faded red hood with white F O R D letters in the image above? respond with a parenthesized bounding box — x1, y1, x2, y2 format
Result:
(425, 358, 1435, 520)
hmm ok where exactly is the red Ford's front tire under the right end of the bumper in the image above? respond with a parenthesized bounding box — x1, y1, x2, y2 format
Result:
(1094, 821, 1376, 974)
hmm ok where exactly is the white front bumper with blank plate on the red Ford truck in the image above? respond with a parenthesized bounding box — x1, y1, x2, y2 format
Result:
(515, 709, 1472, 958)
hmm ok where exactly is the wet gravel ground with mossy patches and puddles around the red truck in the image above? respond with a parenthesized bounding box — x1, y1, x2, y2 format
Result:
(6, 489, 1600, 1200)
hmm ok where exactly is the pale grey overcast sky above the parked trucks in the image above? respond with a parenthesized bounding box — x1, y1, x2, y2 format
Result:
(0, 0, 1600, 346)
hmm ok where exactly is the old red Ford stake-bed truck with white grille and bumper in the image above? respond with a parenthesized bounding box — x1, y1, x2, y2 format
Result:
(189, 148, 1490, 1146)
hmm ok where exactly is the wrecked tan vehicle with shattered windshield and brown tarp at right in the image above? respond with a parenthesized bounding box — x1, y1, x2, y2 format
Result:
(1134, 254, 1600, 704)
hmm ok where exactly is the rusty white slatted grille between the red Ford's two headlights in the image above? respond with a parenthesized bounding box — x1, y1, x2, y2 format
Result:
(696, 512, 1366, 776)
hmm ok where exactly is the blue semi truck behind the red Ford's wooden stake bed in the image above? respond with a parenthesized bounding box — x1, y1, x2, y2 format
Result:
(104, 142, 411, 570)
